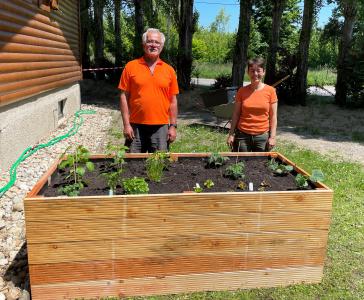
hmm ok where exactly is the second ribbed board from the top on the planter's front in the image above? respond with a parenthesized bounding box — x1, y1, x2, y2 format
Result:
(27, 207, 330, 244)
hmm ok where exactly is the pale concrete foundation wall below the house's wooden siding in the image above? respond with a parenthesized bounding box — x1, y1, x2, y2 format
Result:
(0, 83, 81, 170)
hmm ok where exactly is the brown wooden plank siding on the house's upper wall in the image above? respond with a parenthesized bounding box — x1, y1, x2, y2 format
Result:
(0, 0, 82, 106)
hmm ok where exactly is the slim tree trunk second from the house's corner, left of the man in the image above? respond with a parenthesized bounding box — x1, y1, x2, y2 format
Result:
(93, 0, 105, 79)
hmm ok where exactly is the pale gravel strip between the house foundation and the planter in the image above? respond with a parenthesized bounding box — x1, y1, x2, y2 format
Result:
(0, 104, 115, 300)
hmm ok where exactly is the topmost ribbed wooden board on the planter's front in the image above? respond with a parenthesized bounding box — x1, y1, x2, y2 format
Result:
(24, 191, 331, 221)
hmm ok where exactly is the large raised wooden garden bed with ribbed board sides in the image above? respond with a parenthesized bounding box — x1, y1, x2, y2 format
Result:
(24, 153, 333, 300)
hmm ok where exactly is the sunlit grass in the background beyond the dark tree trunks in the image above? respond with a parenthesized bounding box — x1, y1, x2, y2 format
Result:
(192, 62, 336, 86)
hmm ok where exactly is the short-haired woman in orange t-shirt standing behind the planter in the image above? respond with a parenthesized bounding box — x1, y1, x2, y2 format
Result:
(227, 58, 278, 152)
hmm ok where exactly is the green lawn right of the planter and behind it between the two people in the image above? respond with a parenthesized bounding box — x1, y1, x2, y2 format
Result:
(104, 125, 364, 300)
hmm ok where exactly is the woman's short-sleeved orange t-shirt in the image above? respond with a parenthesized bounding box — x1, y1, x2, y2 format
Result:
(235, 84, 278, 135)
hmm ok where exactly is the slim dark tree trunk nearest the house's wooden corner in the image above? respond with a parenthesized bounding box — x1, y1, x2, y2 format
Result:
(80, 0, 91, 69)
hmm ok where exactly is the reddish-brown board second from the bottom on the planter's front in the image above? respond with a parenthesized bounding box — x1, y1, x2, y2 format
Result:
(30, 248, 325, 284)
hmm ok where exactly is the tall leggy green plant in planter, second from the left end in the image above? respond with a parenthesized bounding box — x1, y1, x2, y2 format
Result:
(102, 143, 128, 193)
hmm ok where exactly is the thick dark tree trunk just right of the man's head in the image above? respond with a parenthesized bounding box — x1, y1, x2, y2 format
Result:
(177, 0, 193, 90)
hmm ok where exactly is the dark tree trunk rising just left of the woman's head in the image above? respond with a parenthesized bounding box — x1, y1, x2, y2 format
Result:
(232, 0, 253, 86)
